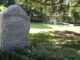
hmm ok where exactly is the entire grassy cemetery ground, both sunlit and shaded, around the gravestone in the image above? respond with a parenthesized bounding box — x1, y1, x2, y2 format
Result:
(0, 23, 80, 60)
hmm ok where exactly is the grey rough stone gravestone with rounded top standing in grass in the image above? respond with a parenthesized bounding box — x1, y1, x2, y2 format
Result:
(0, 5, 29, 50)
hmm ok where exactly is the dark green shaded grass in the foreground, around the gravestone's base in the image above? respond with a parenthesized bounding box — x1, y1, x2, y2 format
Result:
(0, 45, 80, 60)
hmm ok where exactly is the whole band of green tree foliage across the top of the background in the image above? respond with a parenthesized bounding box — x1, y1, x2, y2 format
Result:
(0, 0, 80, 23)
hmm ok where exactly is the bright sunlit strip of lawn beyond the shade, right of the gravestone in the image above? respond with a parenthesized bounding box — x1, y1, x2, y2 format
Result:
(30, 23, 80, 33)
